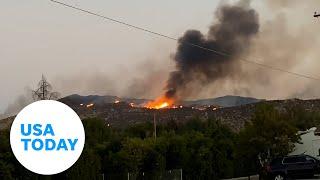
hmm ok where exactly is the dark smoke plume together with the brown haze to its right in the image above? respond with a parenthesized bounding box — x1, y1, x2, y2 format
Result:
(162, 0, 320, 99)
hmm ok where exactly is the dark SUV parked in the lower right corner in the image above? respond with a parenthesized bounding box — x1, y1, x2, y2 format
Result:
(267, 154, 320, 180)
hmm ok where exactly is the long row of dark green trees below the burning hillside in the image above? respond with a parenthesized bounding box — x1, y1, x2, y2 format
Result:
(0, 104, 320, 179)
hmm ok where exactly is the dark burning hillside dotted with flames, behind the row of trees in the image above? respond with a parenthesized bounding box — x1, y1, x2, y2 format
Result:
(0, 95, 320, 131)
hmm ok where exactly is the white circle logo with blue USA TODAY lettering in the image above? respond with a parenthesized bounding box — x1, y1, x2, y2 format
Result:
(10, 100, 85, 175)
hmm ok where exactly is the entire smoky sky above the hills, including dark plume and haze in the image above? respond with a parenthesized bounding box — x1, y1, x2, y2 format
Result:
(0, 0, 320, 114)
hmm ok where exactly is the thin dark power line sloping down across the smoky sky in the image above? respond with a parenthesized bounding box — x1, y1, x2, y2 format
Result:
(50, 0, 320, 81)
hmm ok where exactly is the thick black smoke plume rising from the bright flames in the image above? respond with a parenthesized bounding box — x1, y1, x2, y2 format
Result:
(166, 1, 259, 99)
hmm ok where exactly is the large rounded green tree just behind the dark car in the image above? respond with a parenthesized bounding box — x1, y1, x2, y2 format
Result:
(237, 104, 300, 176)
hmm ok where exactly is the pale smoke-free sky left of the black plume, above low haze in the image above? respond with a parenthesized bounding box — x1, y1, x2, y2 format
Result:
(0, 0, 221, 112)
